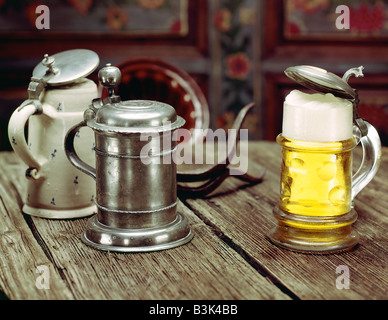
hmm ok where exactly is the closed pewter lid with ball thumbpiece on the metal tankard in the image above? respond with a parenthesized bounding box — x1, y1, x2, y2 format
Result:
(88, 64, 185, 133)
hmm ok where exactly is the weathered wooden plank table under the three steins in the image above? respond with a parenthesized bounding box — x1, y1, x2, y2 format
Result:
(0, 142, 388, 300)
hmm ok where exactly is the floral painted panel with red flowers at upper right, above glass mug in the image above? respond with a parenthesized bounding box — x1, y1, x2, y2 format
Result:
(284, 0, 388, 40)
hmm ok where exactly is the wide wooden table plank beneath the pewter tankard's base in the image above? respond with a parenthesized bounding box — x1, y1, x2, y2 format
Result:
(28, 204, 289, 300)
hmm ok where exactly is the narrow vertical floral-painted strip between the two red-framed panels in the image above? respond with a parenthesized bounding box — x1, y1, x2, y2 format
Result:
(213, 0, 260, 136)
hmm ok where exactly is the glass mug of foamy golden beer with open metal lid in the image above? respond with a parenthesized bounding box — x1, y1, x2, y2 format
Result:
(270, 66, 381, 254)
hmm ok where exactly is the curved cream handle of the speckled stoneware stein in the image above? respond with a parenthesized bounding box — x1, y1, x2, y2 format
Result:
(8, 100, 48, 180)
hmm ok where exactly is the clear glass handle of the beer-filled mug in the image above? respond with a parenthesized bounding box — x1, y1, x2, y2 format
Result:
(352, 119, 382, 201)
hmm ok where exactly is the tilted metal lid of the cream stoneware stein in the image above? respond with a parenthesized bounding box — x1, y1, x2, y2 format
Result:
(32, 49, 100, 87)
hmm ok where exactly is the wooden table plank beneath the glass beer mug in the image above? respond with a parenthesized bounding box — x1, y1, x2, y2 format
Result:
(187, 142, 388, 299)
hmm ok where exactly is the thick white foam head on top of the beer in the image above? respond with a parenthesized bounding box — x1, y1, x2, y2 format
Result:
(282, 90, 353, 142)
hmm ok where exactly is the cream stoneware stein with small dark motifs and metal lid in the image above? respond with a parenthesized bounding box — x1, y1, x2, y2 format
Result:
(8, 49, 99, 219)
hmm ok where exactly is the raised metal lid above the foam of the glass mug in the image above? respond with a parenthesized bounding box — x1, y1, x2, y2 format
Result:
(285, 66, 364, 100)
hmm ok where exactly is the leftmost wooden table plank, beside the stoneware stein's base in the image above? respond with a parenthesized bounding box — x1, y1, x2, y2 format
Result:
(0, 153, 73, 300)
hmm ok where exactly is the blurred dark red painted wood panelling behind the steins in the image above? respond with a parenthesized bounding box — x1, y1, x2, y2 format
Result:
(0, 0, 388, 150)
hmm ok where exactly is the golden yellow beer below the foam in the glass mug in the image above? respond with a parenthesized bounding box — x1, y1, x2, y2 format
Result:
(277, 135, 357, 217)
